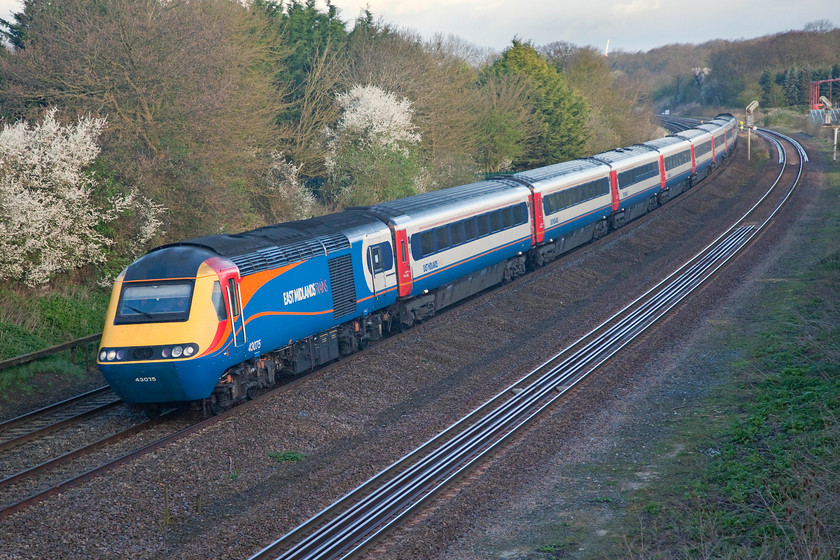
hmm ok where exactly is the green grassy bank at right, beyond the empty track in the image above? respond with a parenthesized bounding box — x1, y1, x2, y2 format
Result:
(612, 139, 840, 559)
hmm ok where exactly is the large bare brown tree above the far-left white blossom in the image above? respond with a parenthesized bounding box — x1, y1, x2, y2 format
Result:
(0, 0, 280, 235)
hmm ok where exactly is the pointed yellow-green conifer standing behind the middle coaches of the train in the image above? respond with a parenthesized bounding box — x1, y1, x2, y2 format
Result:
(489, 39, 589, 168)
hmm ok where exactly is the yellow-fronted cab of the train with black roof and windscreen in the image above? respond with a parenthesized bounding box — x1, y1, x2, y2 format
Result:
(97, 247, 244, 403)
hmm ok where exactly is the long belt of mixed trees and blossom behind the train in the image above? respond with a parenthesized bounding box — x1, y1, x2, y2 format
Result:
(0, 0, 656, 285)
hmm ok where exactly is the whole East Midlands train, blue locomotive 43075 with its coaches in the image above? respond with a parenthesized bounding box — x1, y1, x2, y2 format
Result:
(98, 114, 737, 413)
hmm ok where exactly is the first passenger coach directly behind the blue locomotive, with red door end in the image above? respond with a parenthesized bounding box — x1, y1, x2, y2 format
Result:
(368, 179, 534, 327)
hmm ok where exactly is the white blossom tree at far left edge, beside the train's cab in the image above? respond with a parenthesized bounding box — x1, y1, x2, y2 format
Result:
(0, 108, 163, 286)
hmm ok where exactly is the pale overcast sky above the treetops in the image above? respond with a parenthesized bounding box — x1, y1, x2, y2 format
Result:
(0, 0, 840, 52)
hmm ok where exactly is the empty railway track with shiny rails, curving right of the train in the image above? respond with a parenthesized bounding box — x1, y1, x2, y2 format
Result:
(252, 130, 807, 560)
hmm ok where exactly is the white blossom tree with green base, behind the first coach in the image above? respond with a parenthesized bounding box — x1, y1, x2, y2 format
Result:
(325, 85, 424, 204)
